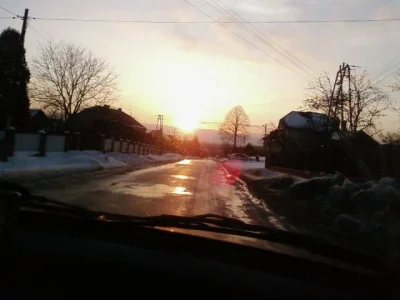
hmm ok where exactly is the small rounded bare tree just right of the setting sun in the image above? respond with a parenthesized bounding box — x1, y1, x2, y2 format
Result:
(219, 106, 250, 149)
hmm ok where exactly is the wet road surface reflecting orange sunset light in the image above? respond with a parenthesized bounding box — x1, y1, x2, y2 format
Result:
(32, 160, 279, 227)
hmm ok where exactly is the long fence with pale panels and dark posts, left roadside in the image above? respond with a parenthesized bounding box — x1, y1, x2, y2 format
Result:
(0, 129, 156, 160)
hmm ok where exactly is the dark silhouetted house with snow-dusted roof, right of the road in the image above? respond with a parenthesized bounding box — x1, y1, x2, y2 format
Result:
(264, 111, 380, 177)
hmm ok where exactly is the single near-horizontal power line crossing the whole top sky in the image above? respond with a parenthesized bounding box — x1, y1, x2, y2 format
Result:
(28, 15, 400, 24)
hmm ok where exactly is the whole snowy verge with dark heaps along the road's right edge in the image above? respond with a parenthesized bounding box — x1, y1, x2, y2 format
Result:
(221, 161, 400, 262)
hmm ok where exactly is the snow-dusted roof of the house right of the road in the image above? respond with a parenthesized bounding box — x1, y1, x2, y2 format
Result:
(280, 111, 333, 131)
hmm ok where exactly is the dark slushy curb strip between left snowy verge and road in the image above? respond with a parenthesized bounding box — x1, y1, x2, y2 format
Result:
(0, 159, 180, 187)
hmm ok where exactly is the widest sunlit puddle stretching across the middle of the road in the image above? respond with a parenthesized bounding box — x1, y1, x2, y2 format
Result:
(108, 184, 193, 198)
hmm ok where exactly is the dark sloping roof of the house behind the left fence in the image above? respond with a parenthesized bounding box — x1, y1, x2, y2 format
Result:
(68, 105, 146, 132)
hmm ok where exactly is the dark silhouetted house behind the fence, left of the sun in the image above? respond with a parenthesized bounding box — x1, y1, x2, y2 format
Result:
(66, 105, 146, 141)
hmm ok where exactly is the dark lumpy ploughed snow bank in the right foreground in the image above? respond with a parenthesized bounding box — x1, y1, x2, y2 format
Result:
(287, 173, 400, 258)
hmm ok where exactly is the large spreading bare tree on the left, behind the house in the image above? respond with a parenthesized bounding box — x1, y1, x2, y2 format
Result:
(30, 42, 117, 120)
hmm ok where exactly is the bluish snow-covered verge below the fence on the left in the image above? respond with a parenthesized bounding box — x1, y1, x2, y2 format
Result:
(0, 150, 183, 182)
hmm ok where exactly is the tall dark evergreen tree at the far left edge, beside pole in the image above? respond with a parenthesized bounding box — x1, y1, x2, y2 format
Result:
(0, 28, 30, 128)
